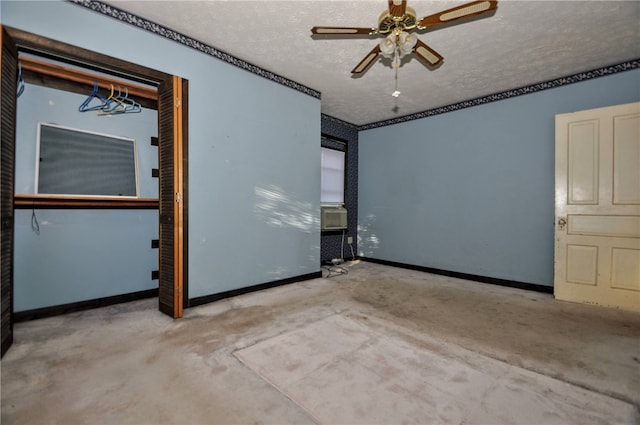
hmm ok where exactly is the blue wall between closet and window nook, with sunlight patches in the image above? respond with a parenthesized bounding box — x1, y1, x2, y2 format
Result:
(0, 1, 320, 306)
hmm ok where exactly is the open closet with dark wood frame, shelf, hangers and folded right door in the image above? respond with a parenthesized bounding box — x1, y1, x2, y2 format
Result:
(3, 27, 187, 321)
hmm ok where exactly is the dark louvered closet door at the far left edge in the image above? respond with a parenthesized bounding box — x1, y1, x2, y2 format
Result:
(0, 28, 18, 356)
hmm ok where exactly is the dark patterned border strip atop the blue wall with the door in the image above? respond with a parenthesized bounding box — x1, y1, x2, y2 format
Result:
(358, 59, 640, 131)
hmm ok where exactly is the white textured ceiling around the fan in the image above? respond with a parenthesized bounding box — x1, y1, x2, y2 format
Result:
(105, 0, 640, 125)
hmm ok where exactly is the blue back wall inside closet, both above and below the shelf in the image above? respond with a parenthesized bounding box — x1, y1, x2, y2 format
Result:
(14, 84, 158, 311)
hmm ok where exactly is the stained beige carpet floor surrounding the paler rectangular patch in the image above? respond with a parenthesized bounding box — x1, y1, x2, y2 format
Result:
(0, 262, 640, 424)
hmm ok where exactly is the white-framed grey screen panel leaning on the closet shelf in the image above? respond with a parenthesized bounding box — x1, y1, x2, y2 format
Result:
(36, 123, 138, 197)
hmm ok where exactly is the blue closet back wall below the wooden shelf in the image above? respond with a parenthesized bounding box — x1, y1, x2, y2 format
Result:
(14, 209, 158, 312)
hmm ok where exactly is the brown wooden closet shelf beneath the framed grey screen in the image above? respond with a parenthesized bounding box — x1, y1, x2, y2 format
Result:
(13, 194, 160, 209)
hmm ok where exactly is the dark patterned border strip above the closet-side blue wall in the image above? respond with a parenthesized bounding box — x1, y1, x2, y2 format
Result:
(68, 0, 320, 99)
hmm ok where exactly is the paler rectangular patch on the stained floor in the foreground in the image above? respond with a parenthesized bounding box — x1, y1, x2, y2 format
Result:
(234, 312, 634, 425)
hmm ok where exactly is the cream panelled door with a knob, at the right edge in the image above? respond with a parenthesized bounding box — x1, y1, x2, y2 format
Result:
(554, 103, 640, 311)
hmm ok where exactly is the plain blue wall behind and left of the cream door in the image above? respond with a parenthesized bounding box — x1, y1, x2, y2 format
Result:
(358, 70, 640, 286)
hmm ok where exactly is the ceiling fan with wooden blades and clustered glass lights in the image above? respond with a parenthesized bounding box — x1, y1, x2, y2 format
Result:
(311, 0, 498, 74)
